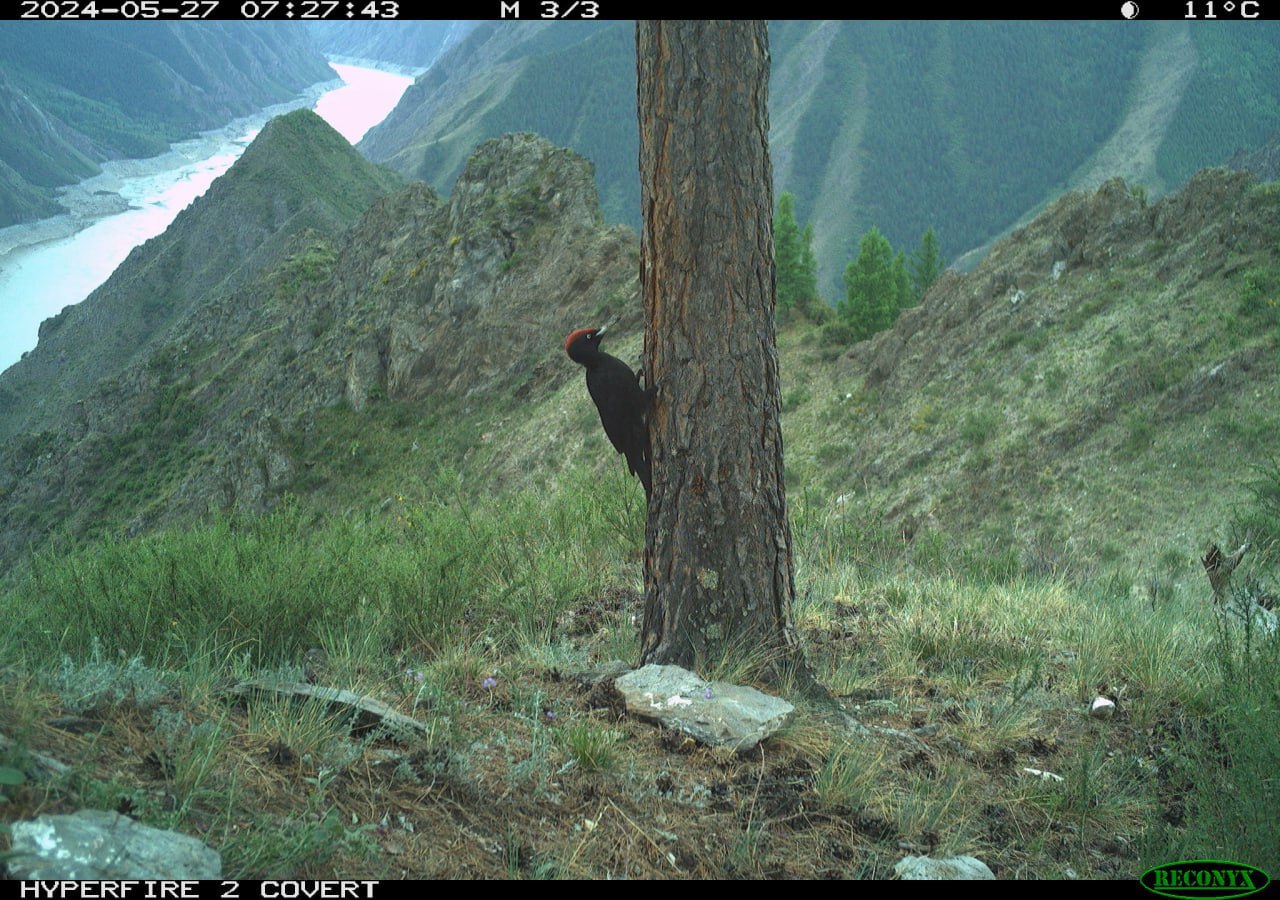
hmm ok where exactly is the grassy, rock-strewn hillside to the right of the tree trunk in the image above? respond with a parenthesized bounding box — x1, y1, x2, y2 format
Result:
(783, 169, 1280, 575)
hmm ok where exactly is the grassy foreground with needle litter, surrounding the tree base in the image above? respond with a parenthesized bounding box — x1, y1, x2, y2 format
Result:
(0, 480, 1280, 878)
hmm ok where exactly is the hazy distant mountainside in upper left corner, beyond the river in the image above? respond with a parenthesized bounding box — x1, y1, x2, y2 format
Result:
(0, 22, 334, 227)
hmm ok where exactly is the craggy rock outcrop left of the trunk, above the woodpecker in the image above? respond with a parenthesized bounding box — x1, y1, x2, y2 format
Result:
(347, 134, 637, 405)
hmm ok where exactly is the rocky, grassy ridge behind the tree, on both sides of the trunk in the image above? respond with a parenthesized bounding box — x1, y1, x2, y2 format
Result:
(0, 107, 1280, 591)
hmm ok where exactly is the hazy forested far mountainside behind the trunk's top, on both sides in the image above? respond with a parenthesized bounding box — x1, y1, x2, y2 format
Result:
(361, 20, 1280, 300)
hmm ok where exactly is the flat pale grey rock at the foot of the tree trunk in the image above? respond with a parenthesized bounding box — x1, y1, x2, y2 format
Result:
(613, 666, 795, 753)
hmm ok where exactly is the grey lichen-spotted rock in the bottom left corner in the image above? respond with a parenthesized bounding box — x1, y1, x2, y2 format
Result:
(8, 809, 223, 880)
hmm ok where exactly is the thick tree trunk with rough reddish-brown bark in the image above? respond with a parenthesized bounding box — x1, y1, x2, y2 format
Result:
(636, 20, 799, 671)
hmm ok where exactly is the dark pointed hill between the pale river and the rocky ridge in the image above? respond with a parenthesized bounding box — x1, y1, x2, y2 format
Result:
(0, 110, 398, 448)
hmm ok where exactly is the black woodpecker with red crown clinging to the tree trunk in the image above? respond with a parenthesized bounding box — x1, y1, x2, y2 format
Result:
(564, 328, 653, 501)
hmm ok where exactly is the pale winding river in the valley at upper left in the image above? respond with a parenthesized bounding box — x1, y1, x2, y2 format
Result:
(0, 63, 413, 370)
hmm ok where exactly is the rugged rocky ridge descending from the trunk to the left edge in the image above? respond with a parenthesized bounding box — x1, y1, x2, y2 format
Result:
(0, 134, 639, 558)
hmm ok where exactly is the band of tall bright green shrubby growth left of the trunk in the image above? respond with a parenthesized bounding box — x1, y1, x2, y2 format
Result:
(0, 471, 634, 664)
